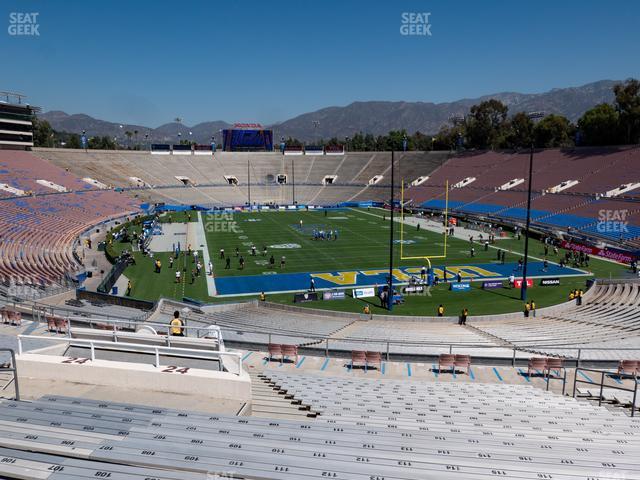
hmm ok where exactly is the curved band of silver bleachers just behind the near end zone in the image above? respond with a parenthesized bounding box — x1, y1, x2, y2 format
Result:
(148, 281, 640, 361)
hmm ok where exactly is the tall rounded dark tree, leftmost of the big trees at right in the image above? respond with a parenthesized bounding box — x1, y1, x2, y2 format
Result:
(463, 99, 509, 149)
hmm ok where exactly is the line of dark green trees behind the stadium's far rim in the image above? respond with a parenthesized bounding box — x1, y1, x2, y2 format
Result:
(33, 79, 640, 152)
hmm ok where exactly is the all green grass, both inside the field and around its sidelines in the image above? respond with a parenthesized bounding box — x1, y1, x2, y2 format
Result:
(112, 208, 629, 315)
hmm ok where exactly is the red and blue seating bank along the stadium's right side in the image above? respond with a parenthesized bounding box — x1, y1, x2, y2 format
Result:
(406, 147, 640, 241)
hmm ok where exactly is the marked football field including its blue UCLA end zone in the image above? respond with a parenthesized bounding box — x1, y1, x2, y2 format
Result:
(201, 208, 584, 295)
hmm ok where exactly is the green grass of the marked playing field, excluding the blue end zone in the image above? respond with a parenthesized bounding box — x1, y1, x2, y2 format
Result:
(204, 209, 510, 277)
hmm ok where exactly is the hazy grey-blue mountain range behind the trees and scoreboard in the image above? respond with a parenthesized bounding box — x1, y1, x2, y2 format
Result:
(39, 80, 620, 144)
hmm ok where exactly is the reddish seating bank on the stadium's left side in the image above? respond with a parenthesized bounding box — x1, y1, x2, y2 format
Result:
(0, 150, 137, 286)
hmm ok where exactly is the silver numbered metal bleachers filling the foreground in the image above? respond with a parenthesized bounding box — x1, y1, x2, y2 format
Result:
(0, 371, 640, 480)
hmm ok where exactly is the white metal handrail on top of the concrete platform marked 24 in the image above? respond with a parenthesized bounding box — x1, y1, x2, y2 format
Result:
(17, 335, 242, 376)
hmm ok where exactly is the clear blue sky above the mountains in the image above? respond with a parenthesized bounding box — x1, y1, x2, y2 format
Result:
(0, 0, 640, 127)
